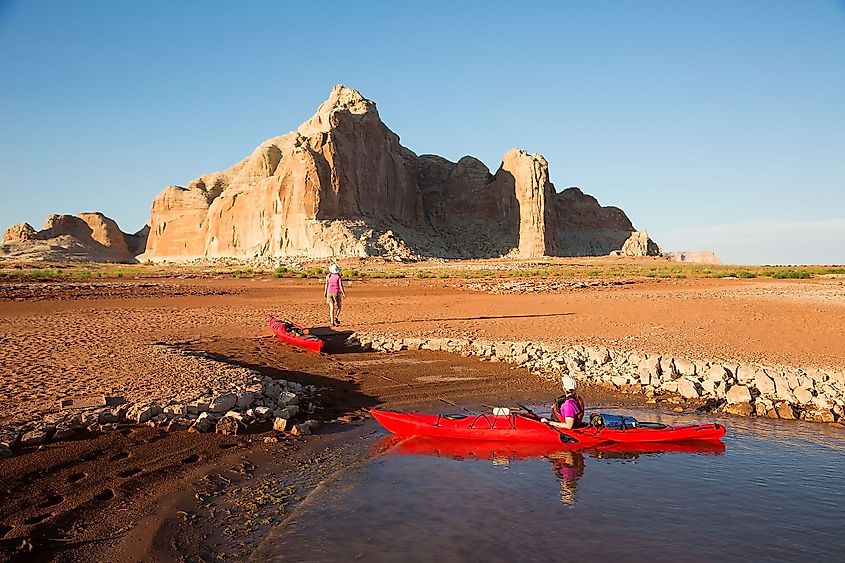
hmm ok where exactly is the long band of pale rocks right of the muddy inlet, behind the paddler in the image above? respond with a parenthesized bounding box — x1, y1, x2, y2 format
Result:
(351, 333, 845, 424)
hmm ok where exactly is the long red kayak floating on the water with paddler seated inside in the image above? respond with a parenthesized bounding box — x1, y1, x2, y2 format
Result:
(370, 409, 725, 447)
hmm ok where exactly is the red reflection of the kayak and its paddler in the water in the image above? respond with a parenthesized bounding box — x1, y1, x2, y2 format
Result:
(371, 434, 725, 506)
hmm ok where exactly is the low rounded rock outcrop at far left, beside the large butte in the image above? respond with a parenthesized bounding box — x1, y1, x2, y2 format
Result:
(0, 213, 147, 263)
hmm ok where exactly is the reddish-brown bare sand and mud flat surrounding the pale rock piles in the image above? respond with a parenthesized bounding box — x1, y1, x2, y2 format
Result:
(0, 278, 845, 561)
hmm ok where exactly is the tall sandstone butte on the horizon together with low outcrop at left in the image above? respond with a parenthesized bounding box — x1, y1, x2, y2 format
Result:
(0, 85, 659, 261)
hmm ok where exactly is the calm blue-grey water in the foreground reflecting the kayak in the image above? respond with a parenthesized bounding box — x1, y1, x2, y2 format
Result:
(256, 410, 845, 561)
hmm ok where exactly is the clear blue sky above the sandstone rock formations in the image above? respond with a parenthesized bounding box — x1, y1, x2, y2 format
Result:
(0, 0, 845, 264)
